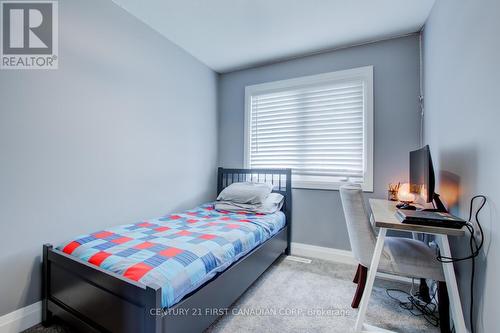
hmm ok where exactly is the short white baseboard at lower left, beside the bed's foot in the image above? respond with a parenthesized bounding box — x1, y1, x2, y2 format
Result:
(0, 301, 42, 333)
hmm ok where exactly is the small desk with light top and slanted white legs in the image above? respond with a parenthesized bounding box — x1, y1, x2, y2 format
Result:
(354, 199, 467, 333)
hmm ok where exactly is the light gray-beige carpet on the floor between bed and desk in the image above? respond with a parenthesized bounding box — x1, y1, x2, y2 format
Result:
(26, 255, 439, 333)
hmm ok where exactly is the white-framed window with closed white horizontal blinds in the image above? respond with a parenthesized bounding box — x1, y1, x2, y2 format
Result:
(245, 66, 373, 191)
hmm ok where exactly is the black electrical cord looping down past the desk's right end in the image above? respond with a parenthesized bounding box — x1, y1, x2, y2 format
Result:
(437, 195, 487, 333)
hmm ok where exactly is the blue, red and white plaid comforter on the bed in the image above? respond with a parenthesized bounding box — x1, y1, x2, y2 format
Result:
(58, 203, 285, 307)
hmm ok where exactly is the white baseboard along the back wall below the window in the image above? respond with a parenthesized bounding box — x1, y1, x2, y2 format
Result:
(291, 242, 412, 283)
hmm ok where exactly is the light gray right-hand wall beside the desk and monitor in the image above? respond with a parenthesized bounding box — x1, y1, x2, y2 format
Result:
(424, 0, 500, 332)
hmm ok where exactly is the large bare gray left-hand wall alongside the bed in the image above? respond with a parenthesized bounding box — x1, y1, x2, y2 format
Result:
(0, 0, 217, 315)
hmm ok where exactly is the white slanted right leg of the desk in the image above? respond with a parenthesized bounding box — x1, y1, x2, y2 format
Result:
(439, 235, 467, 333)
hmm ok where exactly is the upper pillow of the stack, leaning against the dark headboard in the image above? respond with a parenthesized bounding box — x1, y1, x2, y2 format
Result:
(217, 182, 273, 205)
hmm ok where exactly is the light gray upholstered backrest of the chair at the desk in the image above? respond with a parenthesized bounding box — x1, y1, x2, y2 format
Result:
(340, 184, 377, 267)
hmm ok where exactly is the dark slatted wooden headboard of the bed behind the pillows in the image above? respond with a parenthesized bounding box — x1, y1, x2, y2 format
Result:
(217, 168, 292, 254)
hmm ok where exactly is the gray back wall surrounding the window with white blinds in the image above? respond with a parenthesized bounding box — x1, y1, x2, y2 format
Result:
(219, 35, 419, 249)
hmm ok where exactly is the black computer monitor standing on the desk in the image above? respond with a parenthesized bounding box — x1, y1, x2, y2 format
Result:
(410, 145, 435, 202)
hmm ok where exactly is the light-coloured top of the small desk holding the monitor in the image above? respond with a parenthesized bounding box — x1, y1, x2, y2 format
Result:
(370, 199, 465, 236)
